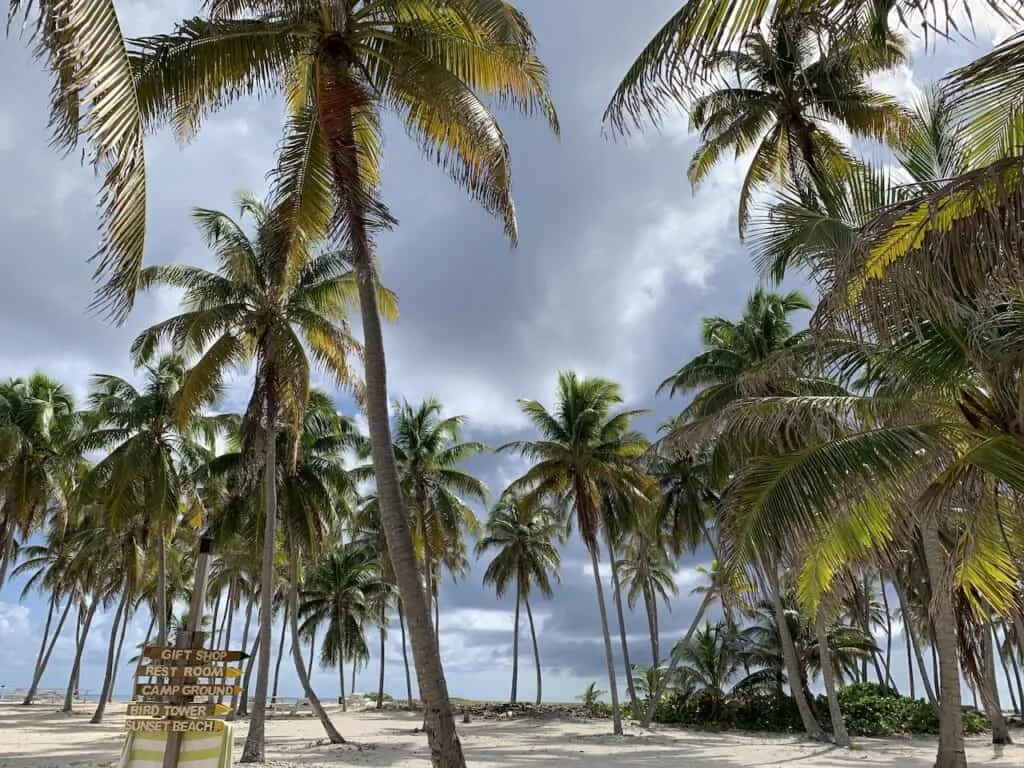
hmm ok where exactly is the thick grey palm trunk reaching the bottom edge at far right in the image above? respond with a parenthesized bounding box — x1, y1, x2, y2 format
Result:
(921, 514, 967, 768)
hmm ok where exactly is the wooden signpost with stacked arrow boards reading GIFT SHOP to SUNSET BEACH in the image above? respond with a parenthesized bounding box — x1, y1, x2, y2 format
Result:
(119, 537, 248, 768)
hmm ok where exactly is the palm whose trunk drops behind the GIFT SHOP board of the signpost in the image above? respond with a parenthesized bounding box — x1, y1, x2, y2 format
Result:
(80, 354, 218, 645)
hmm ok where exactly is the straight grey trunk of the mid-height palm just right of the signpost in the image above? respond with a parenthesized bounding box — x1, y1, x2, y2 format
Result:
(240, 423, 284, 763)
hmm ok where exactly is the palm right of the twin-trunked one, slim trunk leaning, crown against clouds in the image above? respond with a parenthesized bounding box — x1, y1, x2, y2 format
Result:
(499, 372, 656, 734)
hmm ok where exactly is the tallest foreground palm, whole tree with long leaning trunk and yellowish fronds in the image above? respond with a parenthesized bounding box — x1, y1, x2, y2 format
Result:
(135, 0, 557, 766)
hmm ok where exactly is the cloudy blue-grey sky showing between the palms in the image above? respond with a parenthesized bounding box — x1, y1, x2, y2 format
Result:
(0, 0, 1008, 700)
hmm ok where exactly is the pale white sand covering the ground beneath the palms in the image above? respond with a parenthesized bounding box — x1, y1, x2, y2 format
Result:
(0, 703, 1024, 768)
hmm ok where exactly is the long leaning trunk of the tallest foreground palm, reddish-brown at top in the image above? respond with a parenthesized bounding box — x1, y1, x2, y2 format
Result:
(346, 112, 466, 768)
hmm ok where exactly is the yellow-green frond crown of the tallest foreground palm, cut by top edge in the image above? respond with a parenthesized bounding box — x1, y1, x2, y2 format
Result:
(131, 0, 558, 246)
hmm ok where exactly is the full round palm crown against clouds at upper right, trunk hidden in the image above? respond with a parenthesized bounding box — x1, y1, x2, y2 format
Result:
(687, 11, 905, 236)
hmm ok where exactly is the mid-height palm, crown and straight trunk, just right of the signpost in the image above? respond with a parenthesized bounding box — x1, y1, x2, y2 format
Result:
(132, 195, 378, 760)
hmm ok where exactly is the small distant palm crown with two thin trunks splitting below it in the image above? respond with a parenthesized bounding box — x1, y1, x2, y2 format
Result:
(476, 495, 562, 705)
